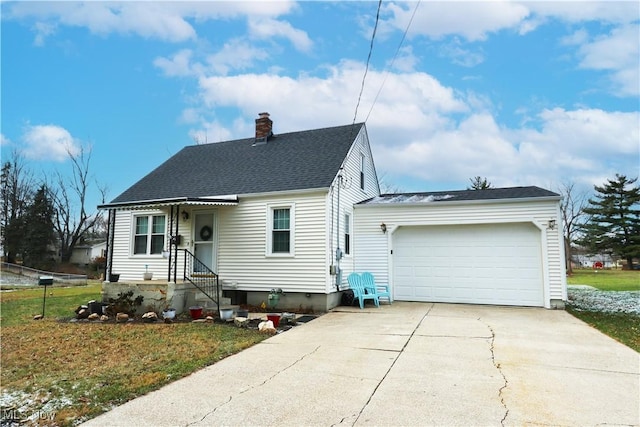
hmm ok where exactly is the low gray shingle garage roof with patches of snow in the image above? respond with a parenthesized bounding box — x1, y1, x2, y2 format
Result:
(360, 186, 560, 205)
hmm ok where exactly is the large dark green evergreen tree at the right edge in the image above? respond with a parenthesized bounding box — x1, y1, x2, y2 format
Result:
(580, 174, 640, 268)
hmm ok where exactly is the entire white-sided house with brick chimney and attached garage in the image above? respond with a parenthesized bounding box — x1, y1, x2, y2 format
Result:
(100, 113, 566, 310)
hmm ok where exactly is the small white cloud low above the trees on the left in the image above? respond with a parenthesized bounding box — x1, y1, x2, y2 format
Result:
(22, 125, 80, 162)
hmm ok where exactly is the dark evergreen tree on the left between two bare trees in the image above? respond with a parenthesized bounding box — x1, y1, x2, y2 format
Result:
(23, 185, 55, 269)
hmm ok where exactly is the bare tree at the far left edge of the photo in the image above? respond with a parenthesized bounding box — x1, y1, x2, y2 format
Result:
(0, 150, 35, 263)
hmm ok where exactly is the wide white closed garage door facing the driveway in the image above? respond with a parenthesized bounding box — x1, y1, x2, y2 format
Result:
(393, 223, 543, 306)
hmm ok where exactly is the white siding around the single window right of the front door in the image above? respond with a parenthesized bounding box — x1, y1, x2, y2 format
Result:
(218, 192, 328, 293)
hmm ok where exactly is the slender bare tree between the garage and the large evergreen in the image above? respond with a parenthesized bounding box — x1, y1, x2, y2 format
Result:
(559, 182, 589, 274)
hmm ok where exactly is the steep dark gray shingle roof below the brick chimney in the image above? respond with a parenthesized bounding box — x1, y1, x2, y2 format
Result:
(111, 123, 364, 203)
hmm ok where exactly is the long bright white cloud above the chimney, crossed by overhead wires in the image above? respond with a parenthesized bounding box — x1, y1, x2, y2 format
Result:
(194, 61, 467, 132)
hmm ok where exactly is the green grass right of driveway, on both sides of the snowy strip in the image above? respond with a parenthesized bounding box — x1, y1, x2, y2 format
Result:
(567, 269, 640, 352)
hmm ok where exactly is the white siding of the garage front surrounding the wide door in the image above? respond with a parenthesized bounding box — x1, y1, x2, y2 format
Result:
(354, 200, 567, 307)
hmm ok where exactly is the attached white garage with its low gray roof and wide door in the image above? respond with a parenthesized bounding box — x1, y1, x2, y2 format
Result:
(352, 187, 567, 308)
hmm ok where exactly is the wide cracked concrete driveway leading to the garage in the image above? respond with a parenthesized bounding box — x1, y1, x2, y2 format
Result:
(85, 302, 640, 426)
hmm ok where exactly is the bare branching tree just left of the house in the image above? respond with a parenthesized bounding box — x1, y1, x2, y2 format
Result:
(52, 147, 107, 263)
